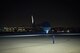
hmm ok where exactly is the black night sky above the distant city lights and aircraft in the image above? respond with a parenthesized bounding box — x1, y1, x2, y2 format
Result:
(0, 0, 80, 27)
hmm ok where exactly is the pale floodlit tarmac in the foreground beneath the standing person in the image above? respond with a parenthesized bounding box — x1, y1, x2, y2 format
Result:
(0, 35, 80, 53)
